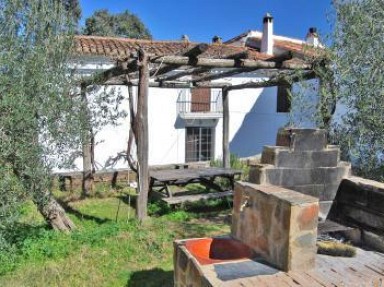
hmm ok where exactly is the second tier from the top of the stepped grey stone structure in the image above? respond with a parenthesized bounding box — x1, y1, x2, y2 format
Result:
(261, 145, 340, 168)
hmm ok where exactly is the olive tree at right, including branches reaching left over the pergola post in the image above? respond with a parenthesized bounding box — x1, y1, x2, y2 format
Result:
(292, 0, 384, 180)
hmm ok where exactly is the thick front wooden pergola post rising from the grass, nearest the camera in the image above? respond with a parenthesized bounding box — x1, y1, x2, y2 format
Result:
(135, 49, 149, 222)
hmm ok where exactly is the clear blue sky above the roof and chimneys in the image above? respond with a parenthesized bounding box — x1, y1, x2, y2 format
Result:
(80, 0, 332, 42)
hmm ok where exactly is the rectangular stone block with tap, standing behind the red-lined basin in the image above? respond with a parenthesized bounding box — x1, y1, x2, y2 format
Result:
(231, 182, 319, 271)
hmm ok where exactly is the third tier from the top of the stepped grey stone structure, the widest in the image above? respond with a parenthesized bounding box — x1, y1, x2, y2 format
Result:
(249, 162, 351, 188)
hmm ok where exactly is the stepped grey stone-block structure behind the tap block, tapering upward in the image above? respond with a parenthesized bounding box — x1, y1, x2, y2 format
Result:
(249, 129, 351, 218)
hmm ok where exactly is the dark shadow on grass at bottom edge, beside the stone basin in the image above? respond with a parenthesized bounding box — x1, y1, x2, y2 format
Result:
(125, 268, 173, 287)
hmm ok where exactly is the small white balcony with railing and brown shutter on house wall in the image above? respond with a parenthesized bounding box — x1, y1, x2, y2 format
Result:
(176, 90, 223, 119)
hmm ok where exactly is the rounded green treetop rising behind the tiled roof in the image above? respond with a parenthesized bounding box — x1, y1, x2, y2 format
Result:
(84, 9, 152, 39)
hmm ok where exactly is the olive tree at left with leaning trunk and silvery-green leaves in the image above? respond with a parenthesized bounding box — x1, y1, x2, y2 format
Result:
(0, 0, 81, 231)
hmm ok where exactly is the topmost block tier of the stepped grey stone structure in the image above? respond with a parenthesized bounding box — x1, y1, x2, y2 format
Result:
(276, 128, 327, 151)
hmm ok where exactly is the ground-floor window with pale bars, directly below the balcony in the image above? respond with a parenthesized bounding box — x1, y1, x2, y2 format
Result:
(185, 127, 214, 162)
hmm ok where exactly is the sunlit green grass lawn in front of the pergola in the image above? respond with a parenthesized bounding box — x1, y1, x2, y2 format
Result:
(0, 189, 230, 287)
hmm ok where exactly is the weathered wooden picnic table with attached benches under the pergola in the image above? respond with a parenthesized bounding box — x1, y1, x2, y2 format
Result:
(149, 167, 241, 205)
